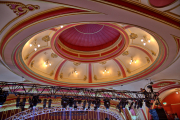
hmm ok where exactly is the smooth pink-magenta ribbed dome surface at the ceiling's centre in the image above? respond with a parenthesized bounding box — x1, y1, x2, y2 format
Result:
(59, 24, 120, 51)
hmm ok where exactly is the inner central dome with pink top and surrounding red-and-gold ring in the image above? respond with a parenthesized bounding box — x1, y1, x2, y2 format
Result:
(51, 23, 129, 63)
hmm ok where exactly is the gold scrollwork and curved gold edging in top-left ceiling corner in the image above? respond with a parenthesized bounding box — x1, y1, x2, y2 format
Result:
(0, 1, 40, 34)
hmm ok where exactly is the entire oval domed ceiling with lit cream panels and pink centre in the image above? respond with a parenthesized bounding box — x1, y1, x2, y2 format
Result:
(2, 23, 167, 87)
